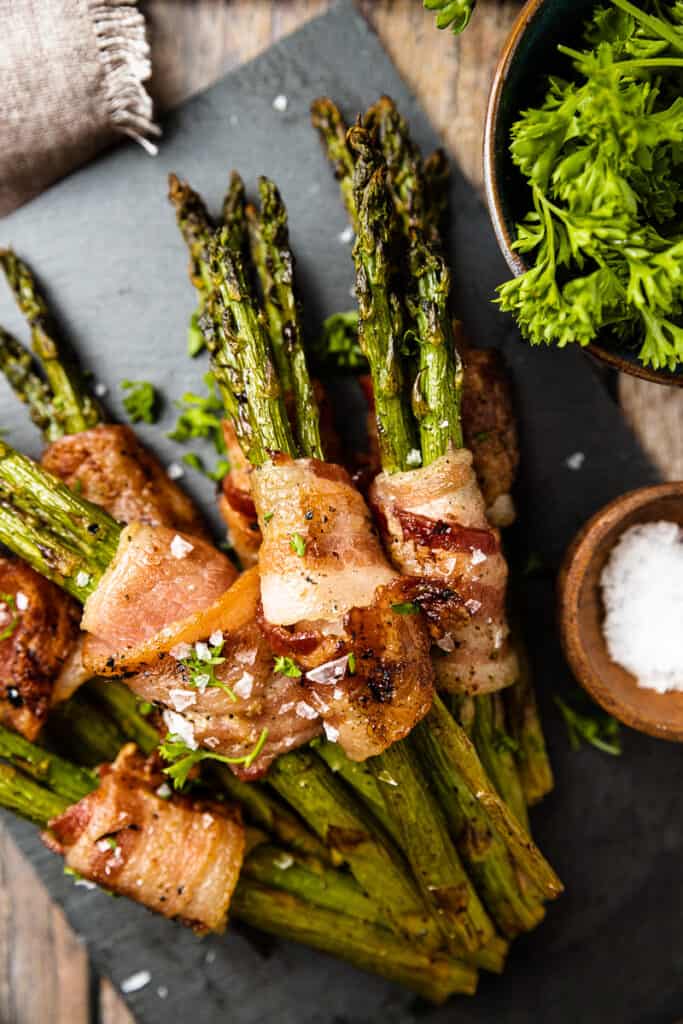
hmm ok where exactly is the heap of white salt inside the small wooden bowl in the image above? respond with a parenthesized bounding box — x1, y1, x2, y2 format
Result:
(600, 520, 683, 693)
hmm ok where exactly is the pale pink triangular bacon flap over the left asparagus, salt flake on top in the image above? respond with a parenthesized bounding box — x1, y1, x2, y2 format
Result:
(81, 523, 238, 675)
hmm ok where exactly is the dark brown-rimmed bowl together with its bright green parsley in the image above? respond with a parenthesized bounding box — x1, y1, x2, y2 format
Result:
(484, 0, 683, 386)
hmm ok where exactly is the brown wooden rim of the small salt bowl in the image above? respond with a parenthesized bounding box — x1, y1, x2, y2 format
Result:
(557, 480, 683, 742)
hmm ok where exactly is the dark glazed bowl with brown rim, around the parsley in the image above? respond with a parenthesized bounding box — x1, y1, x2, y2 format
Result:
(483, 0, 683, 387)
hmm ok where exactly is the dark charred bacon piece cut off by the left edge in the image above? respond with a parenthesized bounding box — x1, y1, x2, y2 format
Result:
(0, 558, 80, 739)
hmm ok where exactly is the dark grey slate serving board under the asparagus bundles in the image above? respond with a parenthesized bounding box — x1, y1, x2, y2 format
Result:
(0, 3, 683, 1024)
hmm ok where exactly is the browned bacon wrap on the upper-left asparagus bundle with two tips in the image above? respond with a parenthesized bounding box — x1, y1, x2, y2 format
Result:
(42, 424, 208, 538)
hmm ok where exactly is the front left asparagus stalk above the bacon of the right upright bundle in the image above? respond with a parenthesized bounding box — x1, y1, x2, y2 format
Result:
(349, 126, 420, 472)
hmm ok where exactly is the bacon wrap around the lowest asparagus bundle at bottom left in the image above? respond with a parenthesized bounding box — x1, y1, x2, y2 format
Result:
(45, 743, 245, 932)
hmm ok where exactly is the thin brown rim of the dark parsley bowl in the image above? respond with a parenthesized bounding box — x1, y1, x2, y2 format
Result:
(483, 0, 683, 387)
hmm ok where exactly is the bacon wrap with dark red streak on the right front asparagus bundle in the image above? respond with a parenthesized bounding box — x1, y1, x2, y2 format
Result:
(371, 449, 517, 693)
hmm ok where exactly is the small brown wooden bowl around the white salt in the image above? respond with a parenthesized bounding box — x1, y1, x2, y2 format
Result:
(558, 481, 683, 741)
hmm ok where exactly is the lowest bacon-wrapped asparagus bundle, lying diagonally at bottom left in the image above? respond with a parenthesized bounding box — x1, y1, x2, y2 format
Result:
(0, 729, 476, 1002)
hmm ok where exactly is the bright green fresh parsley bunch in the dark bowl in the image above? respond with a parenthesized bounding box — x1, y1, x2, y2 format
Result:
(499, 0, 683, 370)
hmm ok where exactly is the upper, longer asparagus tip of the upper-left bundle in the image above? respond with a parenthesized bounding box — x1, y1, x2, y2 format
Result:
(0, 249, 101, 434)
